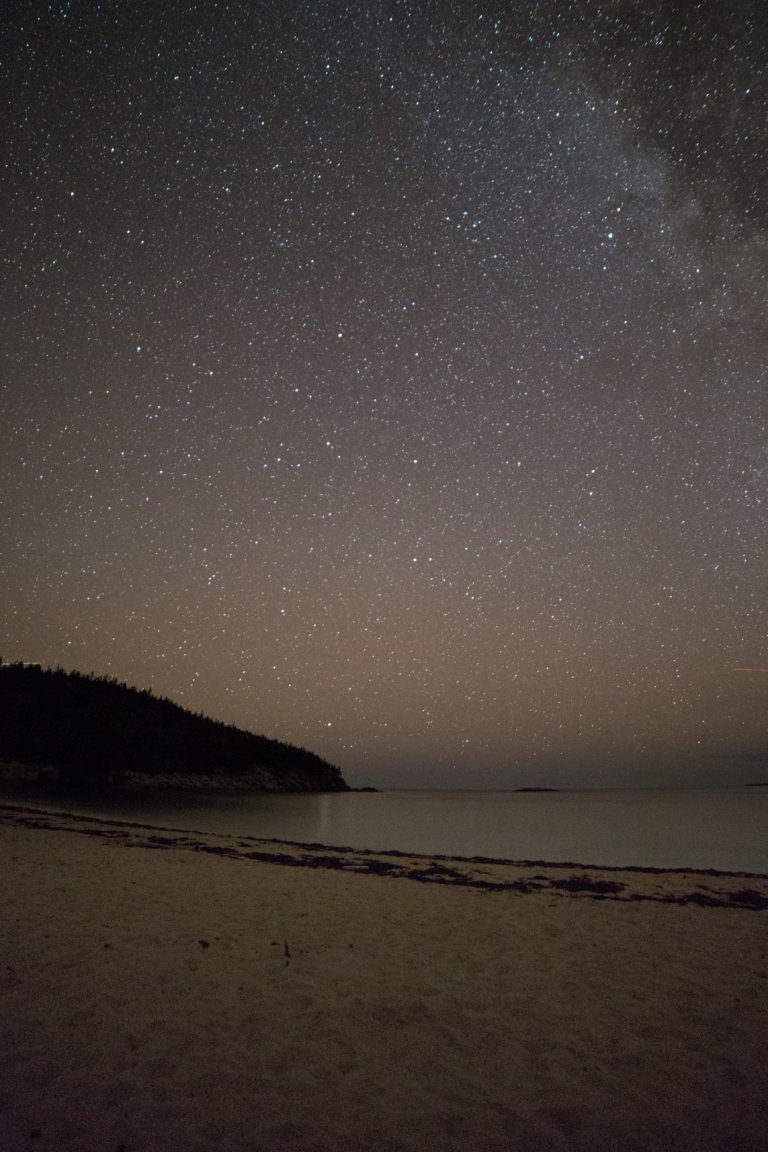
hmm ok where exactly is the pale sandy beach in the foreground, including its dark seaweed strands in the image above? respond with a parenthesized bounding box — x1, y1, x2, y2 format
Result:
(0, 808, 768, 1152)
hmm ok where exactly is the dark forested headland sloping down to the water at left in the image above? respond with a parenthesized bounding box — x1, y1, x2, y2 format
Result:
(0, 661, 349, 793)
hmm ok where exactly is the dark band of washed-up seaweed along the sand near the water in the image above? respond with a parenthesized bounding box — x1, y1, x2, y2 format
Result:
(0, 804, 768, 907)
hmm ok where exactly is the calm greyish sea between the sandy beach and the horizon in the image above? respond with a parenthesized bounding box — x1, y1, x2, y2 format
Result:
(3, 788, 768, 873)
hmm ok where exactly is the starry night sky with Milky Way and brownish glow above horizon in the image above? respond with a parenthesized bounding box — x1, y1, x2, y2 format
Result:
(0, 0, 768, 787)
